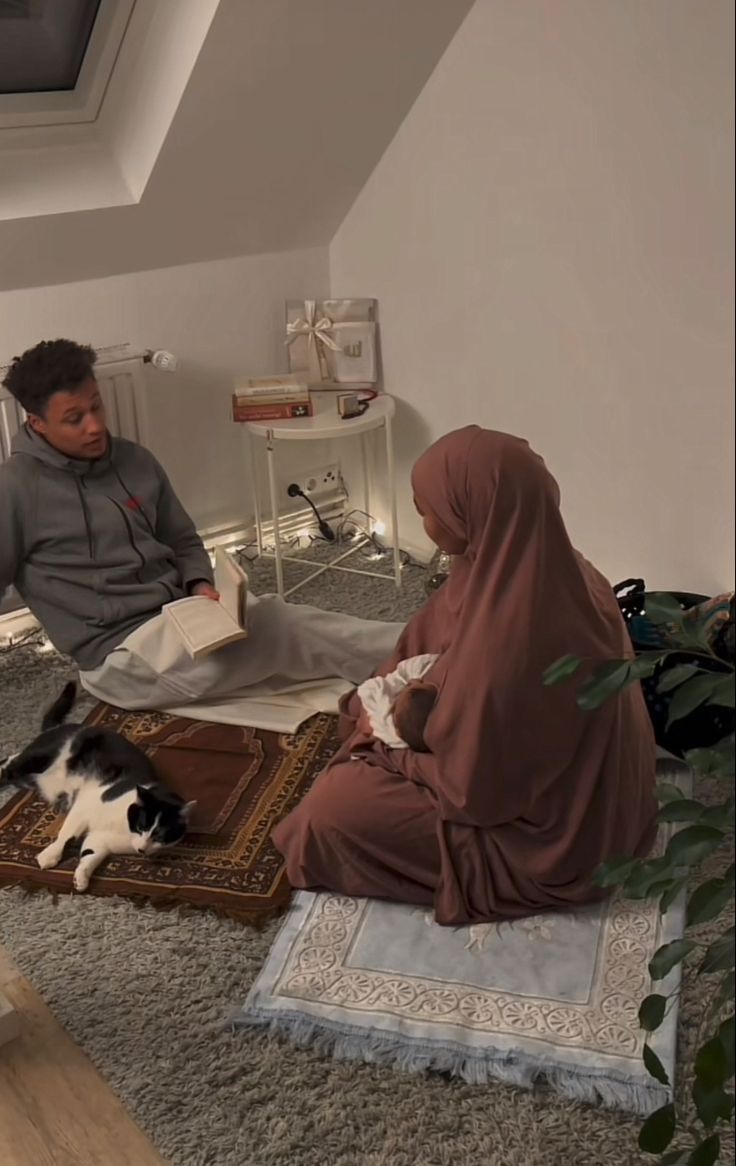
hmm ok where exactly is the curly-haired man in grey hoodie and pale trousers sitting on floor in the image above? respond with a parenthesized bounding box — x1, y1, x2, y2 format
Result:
(0, 340, 401, 711)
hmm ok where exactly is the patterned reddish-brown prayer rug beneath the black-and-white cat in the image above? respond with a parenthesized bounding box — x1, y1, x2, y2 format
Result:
(0, 705, 338, 923)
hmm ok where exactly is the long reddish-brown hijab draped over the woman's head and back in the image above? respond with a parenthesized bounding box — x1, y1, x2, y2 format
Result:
(400, 426, 654, 839)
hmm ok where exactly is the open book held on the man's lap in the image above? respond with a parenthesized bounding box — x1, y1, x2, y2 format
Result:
(162, 547, 248, 660)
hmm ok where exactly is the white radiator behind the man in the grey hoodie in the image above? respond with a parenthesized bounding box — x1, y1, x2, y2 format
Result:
(0, 359, 148, 624)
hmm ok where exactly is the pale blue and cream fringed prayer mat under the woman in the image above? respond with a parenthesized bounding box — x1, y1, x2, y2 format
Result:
(240, 764, 688, 1112)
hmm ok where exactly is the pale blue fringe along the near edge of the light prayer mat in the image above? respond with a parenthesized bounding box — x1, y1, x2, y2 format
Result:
(229, 1009, 672, 1116)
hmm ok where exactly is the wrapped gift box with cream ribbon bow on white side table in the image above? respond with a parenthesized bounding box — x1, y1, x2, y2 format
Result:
(286, 300, 378, 388)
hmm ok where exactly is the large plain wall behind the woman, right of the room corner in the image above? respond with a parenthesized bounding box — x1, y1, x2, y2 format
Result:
(330, 0, 734, 592)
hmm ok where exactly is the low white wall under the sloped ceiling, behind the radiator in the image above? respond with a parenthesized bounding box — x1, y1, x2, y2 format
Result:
(0, 247, 328, 527)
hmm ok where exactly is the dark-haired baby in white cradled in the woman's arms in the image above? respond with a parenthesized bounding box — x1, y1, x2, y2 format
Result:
(358, 655, 437, 753)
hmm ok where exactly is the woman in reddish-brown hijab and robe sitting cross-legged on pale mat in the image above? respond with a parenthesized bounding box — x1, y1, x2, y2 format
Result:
(274, 426, 656, 923)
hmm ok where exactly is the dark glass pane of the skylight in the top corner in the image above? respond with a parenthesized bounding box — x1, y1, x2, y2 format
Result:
(0, 0, 100, 93)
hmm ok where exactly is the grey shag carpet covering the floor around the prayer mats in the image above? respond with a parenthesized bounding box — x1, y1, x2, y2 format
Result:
(0, 548, 734, 1166)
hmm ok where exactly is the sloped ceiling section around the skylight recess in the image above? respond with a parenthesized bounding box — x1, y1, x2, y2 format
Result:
(0, 0, 472, 289)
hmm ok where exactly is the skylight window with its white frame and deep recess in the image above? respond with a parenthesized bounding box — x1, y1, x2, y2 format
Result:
(0, 0, 219, 221)
